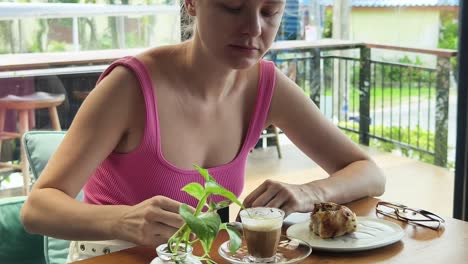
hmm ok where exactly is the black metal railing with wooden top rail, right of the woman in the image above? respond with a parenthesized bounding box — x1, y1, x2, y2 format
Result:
(268, 43, 456, 167)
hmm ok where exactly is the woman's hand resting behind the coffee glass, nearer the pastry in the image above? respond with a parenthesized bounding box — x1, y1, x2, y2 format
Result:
(244, 180, 321, 215)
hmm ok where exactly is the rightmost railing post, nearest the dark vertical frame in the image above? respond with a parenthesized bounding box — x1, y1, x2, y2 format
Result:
(434, 56, 451, 167)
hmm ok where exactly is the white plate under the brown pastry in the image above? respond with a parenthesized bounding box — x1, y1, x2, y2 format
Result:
(286, 216, 405, 252)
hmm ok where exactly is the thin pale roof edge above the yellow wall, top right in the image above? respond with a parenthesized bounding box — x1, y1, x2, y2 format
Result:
(316, 0, 460, 7)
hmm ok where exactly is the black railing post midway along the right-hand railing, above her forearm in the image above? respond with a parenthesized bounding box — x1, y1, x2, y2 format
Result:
(359, 47, 371, 146)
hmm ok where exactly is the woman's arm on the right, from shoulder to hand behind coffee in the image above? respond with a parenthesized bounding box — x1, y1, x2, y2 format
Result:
(245, 67, 385, 212)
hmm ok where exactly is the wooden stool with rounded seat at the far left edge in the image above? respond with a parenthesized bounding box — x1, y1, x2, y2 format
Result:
(0, 92, 65, 195)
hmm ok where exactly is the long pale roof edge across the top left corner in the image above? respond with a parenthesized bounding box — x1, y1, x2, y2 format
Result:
(0, 2, 179, 20)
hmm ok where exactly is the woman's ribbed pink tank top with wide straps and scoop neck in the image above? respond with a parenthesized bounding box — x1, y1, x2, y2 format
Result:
(84, 57, 275, 206)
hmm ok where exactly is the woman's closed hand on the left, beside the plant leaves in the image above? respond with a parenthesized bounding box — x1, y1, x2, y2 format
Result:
(112, 196, 190, 247)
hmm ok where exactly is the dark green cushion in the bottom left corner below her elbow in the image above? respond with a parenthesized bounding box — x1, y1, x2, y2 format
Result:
(0, 196, 45, 264)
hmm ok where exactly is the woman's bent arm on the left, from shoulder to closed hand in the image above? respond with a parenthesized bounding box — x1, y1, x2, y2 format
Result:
(21, 67, 183, 245)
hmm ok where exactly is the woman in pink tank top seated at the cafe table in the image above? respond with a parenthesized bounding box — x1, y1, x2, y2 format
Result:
(22, 0, 385, 260)
